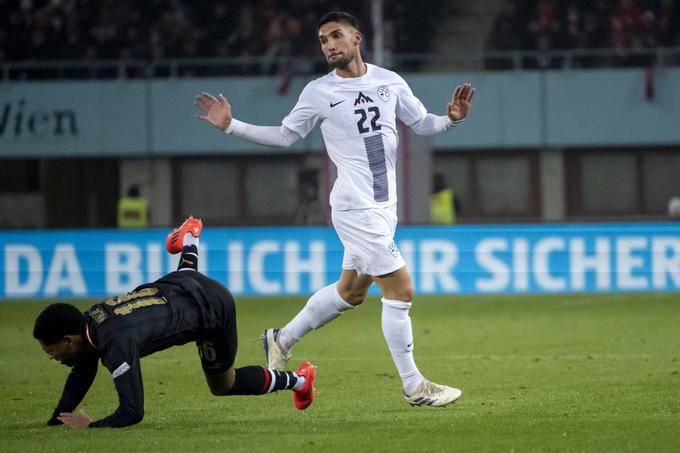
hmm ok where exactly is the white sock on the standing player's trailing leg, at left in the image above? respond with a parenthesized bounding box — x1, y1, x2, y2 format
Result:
(278, 282, 354, 351)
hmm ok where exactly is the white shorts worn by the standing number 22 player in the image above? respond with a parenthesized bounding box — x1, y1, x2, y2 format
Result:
(332, 205, 406, 276)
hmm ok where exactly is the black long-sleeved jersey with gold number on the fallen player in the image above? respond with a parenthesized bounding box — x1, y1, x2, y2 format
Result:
(51, 271, 235, 427)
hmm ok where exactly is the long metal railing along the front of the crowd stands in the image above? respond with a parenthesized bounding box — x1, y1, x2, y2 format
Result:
(5, 47, 680, 81)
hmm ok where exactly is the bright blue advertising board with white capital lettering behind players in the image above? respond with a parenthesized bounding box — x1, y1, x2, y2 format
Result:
(0, 223, 680, 298)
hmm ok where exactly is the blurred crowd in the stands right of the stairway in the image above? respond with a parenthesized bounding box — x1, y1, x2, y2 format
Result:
(487, 0, 680, 69)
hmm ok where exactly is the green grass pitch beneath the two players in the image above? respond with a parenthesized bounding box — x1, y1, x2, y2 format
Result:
(0, 293, 680, 453)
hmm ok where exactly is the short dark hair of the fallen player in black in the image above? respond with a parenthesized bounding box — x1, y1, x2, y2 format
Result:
(33, 302, 85, 346)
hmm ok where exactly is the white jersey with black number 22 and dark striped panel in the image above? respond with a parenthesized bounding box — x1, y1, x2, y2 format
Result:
(283, 64, 436, 210)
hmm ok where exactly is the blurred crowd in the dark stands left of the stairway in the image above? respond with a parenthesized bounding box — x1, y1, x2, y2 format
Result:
(0, 0, 443, 76)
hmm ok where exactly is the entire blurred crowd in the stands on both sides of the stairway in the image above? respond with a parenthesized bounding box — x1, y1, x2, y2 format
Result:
(0, 0, 680, 78)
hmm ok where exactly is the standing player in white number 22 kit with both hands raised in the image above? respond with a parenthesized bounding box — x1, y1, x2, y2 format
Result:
(196, 11, 474, 406)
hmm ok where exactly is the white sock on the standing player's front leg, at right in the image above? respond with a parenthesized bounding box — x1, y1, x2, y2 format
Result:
(382, 297, 423, 395)
